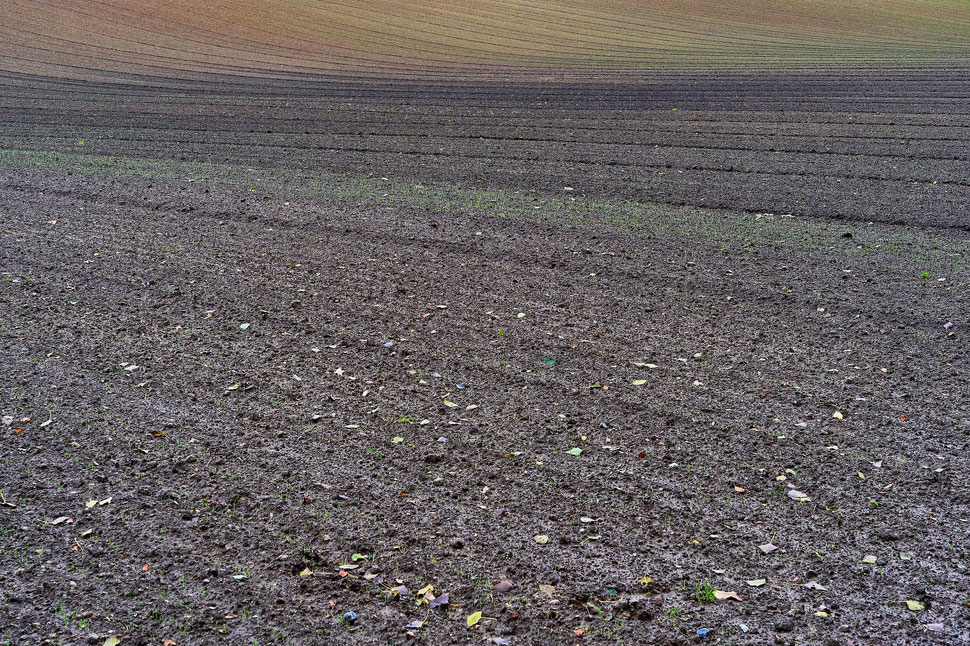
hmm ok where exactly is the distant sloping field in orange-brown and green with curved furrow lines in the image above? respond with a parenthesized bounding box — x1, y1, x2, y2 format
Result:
(0, 0, 970, 82)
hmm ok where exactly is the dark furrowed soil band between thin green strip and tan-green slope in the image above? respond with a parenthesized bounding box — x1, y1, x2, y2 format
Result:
(0, 69, 970, 231)
